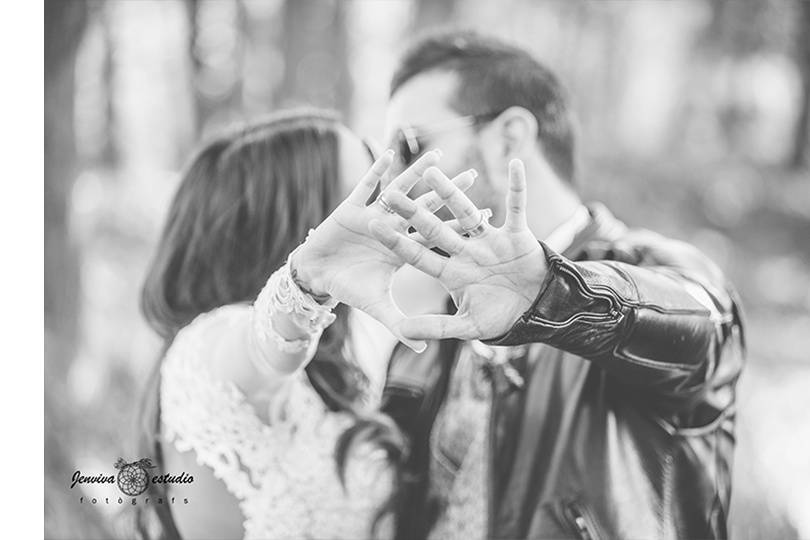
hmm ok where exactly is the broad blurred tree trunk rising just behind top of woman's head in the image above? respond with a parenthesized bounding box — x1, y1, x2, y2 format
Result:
(276, 0, 352, 118)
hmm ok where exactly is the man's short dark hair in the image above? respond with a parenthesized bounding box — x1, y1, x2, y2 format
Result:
(390, 31, 576, 183)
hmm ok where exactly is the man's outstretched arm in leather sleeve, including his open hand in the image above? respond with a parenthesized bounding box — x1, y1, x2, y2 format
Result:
(369, 160, 741, 401)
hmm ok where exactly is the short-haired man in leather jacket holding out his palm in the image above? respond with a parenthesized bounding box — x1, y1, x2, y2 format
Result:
(371, 33, 743, 538)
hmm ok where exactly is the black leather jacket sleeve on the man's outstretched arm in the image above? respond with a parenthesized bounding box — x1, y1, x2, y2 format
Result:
(480, 231, 742, 399)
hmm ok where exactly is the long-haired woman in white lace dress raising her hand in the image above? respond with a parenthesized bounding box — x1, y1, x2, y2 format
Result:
(139, 107, 464, 538)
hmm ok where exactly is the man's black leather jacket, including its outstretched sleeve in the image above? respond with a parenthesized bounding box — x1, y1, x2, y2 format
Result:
(383, 206, 744, 539)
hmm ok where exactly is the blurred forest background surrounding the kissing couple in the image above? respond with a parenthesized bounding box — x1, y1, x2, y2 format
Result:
(45, 0, 810, 538)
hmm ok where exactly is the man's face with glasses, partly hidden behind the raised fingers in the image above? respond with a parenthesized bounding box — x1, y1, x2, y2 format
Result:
(385, 71, 502, 219)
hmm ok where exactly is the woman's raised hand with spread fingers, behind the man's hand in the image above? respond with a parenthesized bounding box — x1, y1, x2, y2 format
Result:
(290, 150, 474, 351)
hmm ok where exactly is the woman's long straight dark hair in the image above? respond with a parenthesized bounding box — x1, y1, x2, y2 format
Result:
(136, 110, 368, 538)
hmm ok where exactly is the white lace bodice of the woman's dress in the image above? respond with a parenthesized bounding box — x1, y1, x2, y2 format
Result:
(160, 305, 391, 539)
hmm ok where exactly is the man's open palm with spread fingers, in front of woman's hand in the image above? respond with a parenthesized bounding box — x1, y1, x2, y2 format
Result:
(370, 160, 546, 339)
